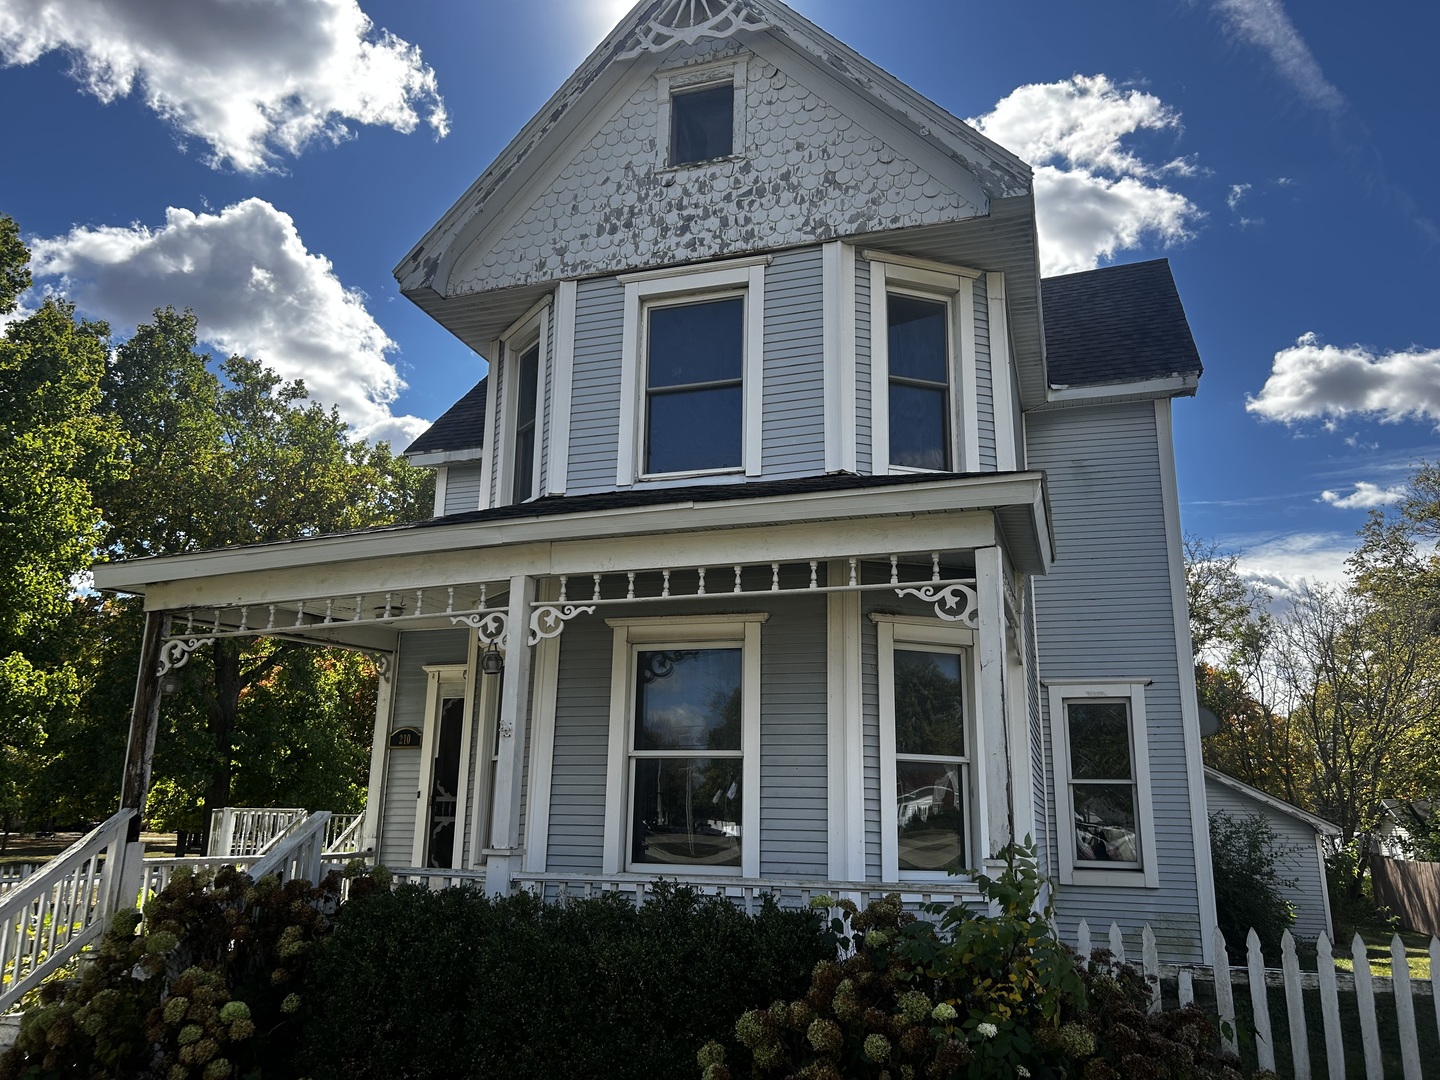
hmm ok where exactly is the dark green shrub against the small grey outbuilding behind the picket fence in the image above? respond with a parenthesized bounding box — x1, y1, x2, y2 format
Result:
(1210, 811, 1295, 958)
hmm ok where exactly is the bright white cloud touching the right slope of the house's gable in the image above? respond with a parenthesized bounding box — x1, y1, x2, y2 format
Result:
(968, 75, 1204, 274)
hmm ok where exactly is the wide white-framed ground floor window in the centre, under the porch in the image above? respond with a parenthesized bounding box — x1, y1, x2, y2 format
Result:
(605, 615, 766, 877)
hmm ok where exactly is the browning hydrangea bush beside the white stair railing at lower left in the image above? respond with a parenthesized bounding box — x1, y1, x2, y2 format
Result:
(0, 868, 348, 1080)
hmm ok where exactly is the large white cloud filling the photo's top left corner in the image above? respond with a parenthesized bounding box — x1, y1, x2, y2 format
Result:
(0, 0, 448, 173)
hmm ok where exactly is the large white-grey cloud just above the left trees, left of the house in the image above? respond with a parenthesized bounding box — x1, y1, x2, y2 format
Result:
(30, 199, 428, 449)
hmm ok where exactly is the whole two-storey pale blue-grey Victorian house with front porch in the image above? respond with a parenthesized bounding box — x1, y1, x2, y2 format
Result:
(87, 0, 1214, 960)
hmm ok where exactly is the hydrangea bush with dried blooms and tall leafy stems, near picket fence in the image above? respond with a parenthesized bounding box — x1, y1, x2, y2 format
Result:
(698, 847, 1084, 1080)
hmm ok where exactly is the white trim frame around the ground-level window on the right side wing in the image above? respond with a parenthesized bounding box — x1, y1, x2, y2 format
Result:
(1045, 678, 1161, 888)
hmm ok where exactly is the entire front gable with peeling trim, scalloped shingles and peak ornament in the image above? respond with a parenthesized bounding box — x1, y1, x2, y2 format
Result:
(395, 0, 1031, 308)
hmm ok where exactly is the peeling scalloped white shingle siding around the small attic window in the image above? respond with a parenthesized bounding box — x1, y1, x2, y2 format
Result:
(446, 42, 986, 295)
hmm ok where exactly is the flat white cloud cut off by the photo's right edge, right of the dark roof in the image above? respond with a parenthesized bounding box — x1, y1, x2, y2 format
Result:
(1246, 333, 1440, 425)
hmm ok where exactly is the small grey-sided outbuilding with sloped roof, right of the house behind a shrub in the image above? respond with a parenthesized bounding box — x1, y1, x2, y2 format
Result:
(1205, 765, 1341, 938)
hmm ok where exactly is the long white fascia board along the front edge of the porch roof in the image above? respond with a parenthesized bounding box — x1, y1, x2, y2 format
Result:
(95, 472, 1044, 592)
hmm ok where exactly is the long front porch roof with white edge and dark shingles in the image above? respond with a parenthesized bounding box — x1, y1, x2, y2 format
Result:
(95, 471, 1053, 606)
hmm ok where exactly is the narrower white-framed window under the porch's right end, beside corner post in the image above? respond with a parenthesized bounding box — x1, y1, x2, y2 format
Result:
(874, 616, 976, 881)
